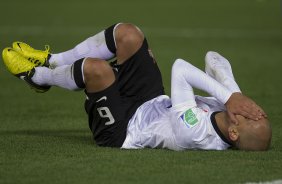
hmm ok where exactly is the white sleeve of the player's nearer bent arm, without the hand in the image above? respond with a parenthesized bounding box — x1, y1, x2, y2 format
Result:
(171, 59, 232, 108)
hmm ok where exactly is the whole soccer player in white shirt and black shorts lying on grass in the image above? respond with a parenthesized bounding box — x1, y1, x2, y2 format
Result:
(3, 24, 271, 150)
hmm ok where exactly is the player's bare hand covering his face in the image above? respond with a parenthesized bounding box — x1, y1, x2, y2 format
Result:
(225, 93, 267, 124)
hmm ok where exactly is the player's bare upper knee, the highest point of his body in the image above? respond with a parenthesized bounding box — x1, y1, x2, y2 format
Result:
(115, 23, 144, 48)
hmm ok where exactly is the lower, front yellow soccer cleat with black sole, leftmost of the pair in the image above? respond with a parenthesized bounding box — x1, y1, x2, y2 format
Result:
(2, 48, 50, 93)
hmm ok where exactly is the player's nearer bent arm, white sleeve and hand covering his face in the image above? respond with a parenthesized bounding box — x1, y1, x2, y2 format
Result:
(172, 59, 266, 123)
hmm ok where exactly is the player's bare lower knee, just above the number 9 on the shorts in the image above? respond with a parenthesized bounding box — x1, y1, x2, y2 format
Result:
(83, 58, 113, 83)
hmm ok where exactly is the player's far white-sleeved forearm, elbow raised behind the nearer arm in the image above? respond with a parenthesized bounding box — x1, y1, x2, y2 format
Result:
(205, 51, 241, 92)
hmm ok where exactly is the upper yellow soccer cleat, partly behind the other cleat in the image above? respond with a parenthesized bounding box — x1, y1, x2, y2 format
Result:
(13, 41, 51, 67)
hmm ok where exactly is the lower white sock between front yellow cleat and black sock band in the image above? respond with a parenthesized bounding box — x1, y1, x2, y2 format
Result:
(31, 65, 81, 90)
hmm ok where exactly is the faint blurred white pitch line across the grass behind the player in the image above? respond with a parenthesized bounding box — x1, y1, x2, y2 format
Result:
(0, 26, 282, 39)
